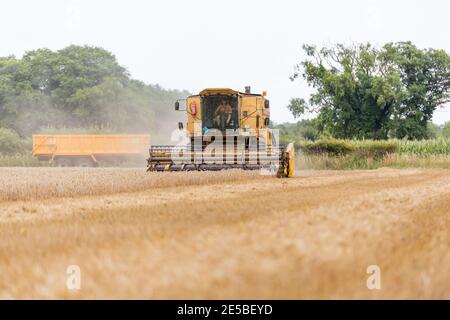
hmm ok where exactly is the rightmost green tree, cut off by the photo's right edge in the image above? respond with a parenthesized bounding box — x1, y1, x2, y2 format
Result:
(381, 42, 450, 138)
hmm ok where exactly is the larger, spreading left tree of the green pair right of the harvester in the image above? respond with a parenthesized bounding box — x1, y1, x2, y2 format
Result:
(289, 44, 403, 139)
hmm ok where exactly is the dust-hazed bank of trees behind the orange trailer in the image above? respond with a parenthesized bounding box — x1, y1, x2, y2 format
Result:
(0, 45, 189, 141)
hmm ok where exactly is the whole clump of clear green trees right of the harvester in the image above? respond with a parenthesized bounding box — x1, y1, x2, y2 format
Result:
(288, 42, 450, 139)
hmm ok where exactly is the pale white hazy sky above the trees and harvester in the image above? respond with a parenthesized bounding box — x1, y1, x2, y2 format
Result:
(0, 0, 450, 123)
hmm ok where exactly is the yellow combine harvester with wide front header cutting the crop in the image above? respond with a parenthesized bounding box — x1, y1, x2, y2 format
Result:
(148, 87, 295, 177)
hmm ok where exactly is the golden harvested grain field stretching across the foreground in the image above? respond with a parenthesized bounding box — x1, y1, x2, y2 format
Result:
(0, 168, 450, 299)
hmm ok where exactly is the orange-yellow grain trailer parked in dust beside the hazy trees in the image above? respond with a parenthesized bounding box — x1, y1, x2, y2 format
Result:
(32, 134, 150, 167)
